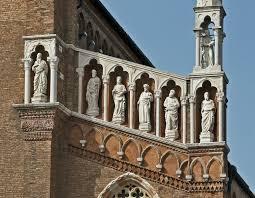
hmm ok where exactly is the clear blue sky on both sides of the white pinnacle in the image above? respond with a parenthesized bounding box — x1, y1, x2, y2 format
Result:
(101, 0, 255, 191)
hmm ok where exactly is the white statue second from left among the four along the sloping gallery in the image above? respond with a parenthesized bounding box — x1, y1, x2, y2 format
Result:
(112, 76, 127, 124)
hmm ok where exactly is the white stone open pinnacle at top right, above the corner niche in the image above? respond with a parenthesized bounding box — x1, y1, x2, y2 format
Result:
(193, 0, 226, 73)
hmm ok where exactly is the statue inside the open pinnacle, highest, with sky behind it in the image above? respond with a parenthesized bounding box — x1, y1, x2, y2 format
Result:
(201, 30, 215, 68)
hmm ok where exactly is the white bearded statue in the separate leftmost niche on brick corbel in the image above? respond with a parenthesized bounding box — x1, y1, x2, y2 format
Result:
(32, 53, 48, 103)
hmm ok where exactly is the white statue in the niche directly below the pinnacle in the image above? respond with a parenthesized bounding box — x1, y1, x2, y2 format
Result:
(200, 92, 215, 142)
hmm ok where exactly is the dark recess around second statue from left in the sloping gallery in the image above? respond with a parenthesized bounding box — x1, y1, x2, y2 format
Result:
(108, 66, 130, 125)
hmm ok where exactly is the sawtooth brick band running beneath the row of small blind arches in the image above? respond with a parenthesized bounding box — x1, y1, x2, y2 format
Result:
(66, 145, 225, 192)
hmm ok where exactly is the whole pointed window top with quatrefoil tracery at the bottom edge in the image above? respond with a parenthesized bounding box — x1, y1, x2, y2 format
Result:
(98, 173, 159, 198)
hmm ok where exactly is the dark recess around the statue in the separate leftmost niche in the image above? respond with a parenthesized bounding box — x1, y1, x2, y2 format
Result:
(30, 45, 50, 100)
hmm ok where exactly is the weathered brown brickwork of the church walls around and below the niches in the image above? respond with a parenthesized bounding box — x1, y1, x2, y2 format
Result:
(0, 0, 254, 198)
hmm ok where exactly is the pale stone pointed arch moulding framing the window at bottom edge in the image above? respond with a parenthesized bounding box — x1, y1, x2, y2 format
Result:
(97, 172, 159, 198)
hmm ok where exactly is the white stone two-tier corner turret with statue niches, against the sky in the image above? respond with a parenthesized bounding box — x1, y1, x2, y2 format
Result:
(189, 0, 228, 143)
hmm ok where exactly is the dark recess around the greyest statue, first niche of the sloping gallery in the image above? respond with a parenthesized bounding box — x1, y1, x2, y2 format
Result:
(82, 59, 103, 118)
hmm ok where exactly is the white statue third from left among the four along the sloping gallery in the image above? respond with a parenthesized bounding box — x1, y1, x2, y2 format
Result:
(137, 84, 153, 132)
